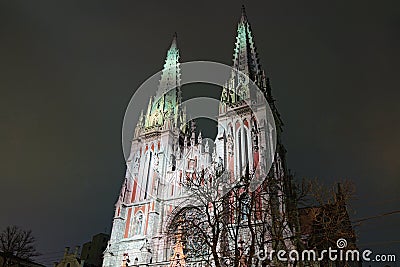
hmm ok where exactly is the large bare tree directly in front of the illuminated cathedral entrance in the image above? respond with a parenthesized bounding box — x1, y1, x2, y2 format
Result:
(167, 164, 297, 267)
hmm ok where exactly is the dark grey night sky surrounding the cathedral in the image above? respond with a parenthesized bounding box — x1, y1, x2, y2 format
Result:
(0, 0, 400, 263)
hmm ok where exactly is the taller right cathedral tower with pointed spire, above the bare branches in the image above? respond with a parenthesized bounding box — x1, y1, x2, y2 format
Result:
(216, 6, 296, 253)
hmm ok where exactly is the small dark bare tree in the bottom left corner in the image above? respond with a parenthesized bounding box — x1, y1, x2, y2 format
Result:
(0, 225, 39, 267)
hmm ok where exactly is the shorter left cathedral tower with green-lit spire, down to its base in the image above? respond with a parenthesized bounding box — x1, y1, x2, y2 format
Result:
(103, 34, 185, 267)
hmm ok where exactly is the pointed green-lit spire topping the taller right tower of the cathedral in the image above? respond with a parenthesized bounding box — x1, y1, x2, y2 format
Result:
(233, 5, 261, 80)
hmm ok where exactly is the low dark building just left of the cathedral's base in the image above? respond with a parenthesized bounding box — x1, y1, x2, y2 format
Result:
(81, 233, 110, 267)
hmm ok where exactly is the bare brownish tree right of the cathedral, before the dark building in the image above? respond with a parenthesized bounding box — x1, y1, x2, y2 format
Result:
(300, 180, 357, 266)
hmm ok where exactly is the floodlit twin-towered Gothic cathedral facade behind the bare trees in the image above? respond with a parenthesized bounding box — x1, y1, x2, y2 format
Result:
(103, 6, 295, 267)
